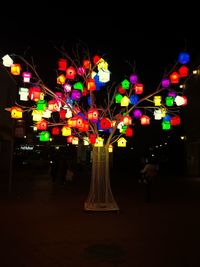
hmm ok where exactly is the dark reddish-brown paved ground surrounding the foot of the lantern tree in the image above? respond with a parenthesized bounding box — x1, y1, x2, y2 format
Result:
(0, 166, 200, 267)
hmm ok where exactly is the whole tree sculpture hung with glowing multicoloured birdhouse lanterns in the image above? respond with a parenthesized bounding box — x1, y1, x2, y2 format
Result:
(3, 44, 190, 211)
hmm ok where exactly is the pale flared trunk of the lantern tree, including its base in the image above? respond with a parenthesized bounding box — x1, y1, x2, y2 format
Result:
(84, 147, 119, 211)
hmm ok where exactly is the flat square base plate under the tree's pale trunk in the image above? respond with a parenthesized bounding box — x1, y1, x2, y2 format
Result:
(84, 202, 119, 211)
